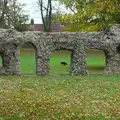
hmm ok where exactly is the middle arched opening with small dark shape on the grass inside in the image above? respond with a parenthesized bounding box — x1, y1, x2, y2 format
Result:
(50, 50, 71, 74)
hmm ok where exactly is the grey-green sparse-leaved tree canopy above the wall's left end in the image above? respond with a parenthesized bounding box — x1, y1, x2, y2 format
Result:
(0, 0, 29, 31)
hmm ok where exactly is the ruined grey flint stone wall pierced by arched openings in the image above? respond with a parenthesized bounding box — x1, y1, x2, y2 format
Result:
(0, 25, 120, 76)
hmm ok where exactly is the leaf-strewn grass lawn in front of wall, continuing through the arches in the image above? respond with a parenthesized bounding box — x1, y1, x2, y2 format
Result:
(0, 50, 120, 120)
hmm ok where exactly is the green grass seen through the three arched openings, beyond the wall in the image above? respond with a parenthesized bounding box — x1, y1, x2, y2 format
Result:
(21, 50, 105, 74)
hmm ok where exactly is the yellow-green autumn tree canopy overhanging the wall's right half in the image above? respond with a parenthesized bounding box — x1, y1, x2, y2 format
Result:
(58, 0, 120, 31)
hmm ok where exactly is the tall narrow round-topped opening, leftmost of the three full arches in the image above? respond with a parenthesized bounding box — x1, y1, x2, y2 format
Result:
(20, 42, 36, 74)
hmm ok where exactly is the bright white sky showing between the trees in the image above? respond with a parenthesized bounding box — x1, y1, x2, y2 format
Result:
(18, 0, 70, 24)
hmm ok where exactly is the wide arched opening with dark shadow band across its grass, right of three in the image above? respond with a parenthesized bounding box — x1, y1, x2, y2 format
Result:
(87, 49, 105, 74)
